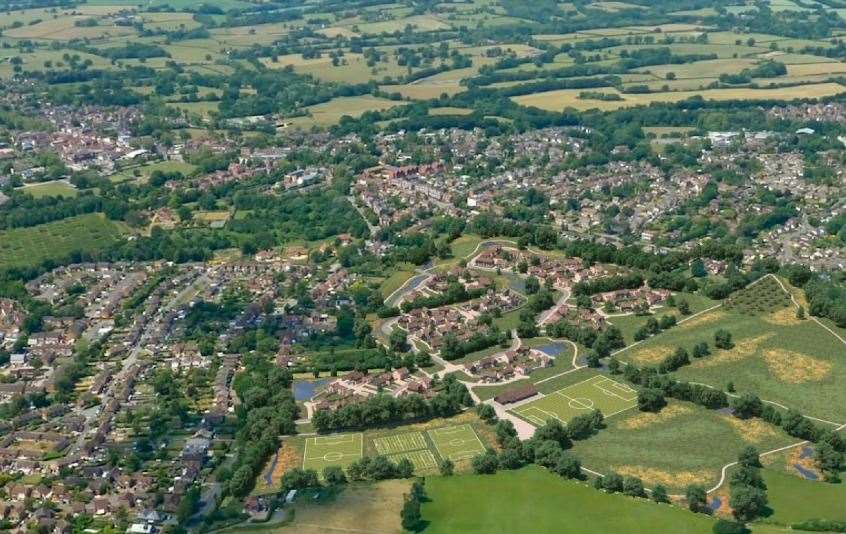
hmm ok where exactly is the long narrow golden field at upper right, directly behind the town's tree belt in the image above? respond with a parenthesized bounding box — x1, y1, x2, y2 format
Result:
(512, 83, 846, 111)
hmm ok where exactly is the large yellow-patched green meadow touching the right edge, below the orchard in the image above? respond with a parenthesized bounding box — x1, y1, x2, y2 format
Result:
(617, 280, 846, 423)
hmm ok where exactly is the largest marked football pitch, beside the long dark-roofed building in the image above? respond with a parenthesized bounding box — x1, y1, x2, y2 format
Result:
(512, 375, 637, 426)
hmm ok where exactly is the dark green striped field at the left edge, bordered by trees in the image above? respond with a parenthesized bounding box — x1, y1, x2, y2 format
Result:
(0, 214, 120, 268)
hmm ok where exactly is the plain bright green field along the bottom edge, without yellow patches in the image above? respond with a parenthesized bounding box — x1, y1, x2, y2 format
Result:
(422, 466, 714, 534)
